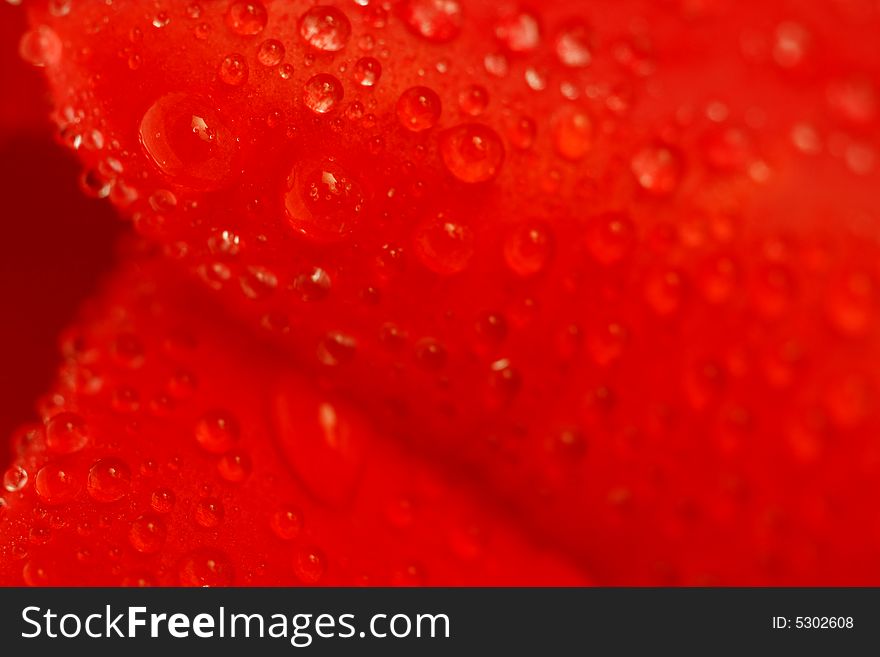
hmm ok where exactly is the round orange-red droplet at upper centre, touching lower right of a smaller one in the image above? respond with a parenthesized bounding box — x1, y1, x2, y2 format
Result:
(440, 123, 504, 183)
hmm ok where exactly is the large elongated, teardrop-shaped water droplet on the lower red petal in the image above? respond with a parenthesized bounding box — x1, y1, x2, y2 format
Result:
(274, 387, 368, 507)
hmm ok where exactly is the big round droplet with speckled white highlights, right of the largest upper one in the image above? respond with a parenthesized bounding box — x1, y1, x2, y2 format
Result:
(284, 158, 364, 242)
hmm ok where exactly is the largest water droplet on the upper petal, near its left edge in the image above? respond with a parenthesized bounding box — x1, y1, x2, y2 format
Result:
(140, 93, 236, 190)
